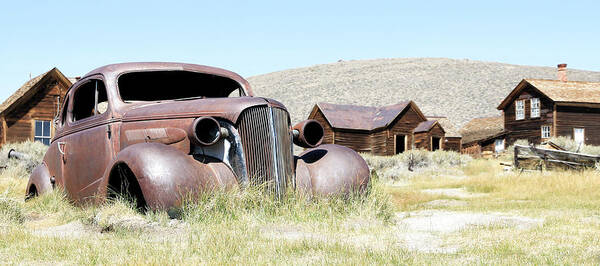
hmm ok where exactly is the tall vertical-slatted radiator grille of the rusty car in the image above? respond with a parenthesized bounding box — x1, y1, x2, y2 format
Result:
(238, 106, 294, 197)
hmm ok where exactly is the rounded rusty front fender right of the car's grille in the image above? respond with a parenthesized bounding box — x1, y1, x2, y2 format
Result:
(295, 144, 370, 196)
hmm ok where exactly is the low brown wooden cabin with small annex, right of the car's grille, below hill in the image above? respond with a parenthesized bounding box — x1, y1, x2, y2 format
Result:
(308, 101, 444, 155)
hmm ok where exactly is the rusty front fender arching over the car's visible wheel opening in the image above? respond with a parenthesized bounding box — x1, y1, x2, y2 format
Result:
(101, 143, 237, 209)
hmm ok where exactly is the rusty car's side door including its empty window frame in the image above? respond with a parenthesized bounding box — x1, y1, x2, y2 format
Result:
(59, 77, 114, 202)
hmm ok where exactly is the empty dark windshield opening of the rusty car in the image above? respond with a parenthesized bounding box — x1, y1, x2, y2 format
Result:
(118, 71, 244, 102)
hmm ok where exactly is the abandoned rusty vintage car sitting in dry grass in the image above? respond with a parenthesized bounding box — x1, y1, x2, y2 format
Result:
(27, 63, 369, 209)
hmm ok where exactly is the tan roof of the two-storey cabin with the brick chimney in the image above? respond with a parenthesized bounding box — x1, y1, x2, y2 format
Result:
(498, 79, 600, 110)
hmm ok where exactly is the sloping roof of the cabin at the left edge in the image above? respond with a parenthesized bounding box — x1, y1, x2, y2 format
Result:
(0, 68, 72, 113)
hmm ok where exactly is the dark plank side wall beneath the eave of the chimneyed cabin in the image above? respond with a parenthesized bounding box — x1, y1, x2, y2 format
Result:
(556, 106, 600, 145)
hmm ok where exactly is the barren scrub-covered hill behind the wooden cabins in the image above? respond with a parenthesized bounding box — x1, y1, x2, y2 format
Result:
(248, 58, 600, 127)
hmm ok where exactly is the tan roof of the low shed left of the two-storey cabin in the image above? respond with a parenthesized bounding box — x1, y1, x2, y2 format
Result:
(460, 116, 504, 144)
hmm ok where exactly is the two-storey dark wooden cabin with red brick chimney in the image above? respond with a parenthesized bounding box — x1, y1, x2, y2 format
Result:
(497, 64, 600, 148)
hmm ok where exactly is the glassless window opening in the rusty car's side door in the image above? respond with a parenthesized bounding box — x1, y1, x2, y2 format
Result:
(73, 79, 108, 121)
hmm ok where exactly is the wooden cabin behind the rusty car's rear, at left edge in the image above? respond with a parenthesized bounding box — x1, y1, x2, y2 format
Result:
(0, 68, 74, 145)
